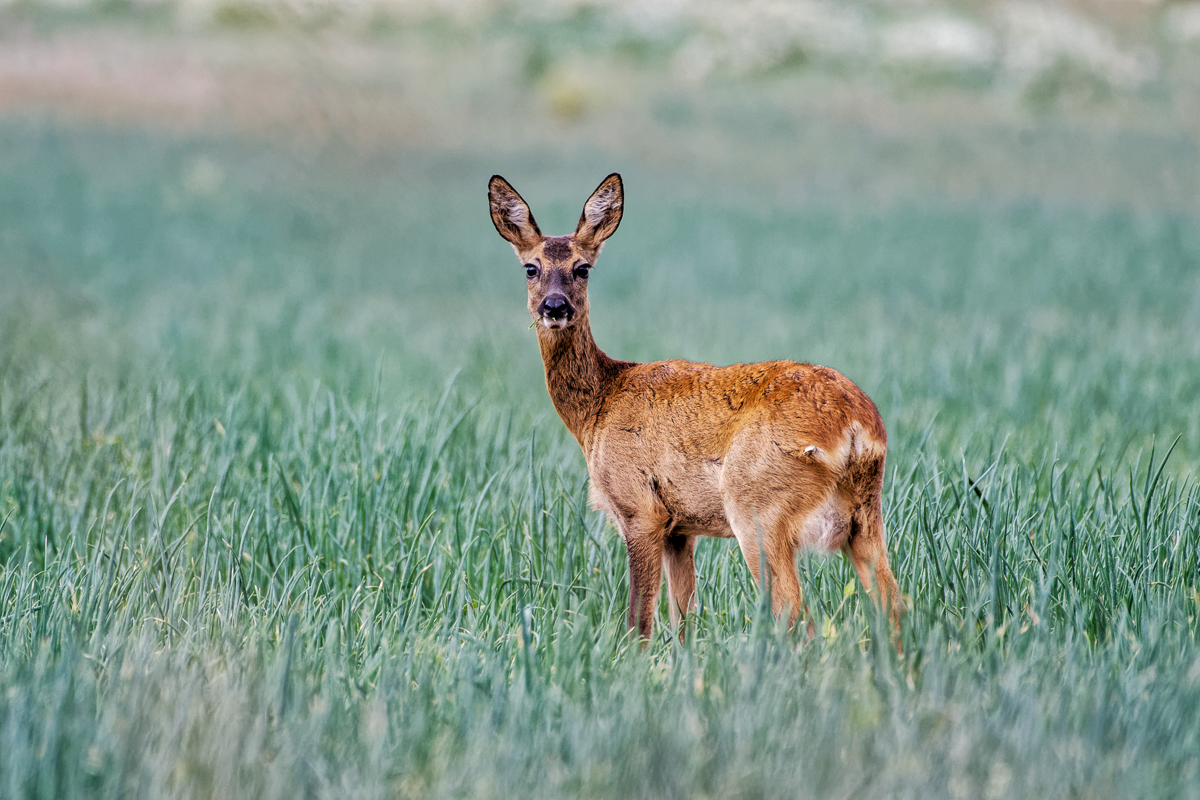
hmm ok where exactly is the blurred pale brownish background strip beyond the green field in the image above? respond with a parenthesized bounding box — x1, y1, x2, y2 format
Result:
(0, 0, 1200, 209)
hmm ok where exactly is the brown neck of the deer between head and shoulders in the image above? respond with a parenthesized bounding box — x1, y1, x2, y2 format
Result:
(538, 317, 623, 453)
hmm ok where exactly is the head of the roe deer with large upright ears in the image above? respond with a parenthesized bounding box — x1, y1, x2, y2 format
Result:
(487, 173, 624, 331)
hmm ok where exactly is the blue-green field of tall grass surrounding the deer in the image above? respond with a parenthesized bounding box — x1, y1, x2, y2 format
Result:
(0, 121, 1200, 799)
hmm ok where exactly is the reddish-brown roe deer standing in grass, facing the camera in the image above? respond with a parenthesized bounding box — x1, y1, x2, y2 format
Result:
(487, 173, 901, 639)
